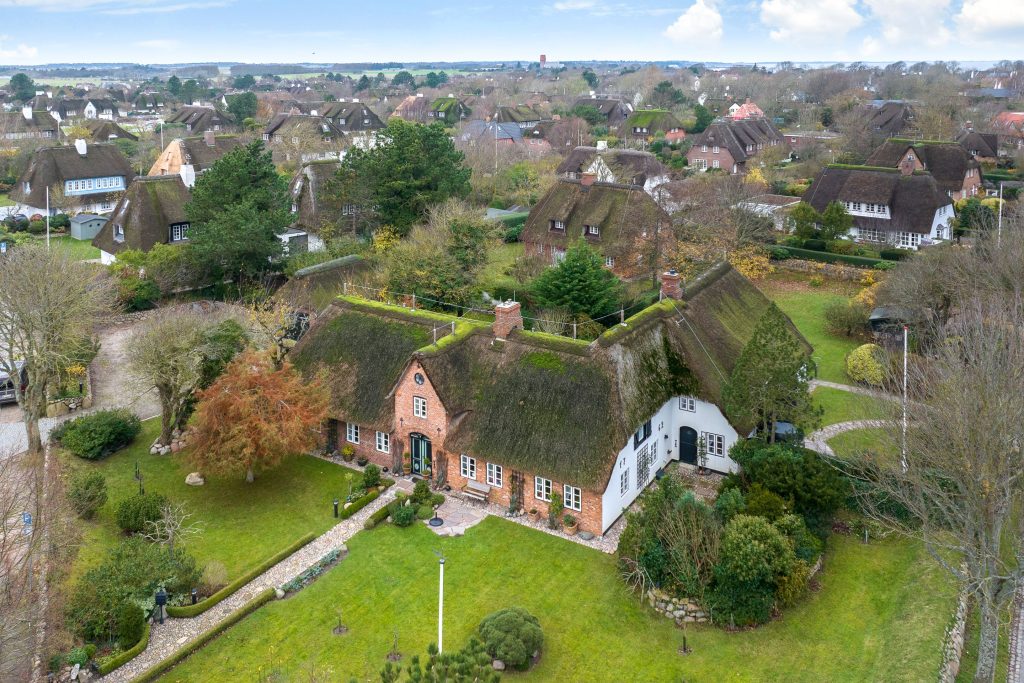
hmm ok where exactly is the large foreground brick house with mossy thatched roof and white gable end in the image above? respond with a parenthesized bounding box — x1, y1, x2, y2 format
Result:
(293, 263, 810, 535)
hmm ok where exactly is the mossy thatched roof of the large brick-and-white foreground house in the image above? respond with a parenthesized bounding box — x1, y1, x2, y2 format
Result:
(286, 264, 798, 490)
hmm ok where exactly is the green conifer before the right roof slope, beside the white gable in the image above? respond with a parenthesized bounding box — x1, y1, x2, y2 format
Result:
(722, 303, 820, 442)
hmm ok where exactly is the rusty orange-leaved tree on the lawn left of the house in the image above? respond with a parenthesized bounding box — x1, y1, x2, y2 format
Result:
(191, 351, 329, 481)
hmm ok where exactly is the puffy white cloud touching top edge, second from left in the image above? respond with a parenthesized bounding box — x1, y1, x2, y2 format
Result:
(761, 0, 864, 44)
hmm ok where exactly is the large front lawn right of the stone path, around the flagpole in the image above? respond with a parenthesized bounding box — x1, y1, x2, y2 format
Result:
(163, 517, 954, 683)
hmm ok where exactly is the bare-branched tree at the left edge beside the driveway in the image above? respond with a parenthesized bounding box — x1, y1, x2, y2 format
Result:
(0, 246, 114, 454)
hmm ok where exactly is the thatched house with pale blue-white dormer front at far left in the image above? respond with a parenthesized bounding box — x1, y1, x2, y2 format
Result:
(10, 140, 135, 215)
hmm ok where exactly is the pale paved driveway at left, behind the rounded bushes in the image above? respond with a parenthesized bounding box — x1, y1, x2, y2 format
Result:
(0, 321, 160, 457)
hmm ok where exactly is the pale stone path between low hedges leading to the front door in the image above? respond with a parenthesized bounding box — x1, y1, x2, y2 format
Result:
(97, 486, 397, 683)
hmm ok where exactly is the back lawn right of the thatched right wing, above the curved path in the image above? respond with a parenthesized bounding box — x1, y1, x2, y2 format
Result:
(758, 278, 860, 384)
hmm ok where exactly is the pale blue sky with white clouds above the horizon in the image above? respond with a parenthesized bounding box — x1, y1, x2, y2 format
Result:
(0, 0, 1024, 65)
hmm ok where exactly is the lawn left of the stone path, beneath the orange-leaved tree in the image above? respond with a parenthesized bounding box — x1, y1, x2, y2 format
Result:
(65, 419, 357, 581)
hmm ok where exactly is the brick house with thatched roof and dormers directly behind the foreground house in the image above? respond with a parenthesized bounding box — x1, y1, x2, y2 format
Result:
(520, 172, 671, 278)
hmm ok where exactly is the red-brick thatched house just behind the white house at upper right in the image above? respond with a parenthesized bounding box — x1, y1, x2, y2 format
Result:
(864, 137, 981, 202)
